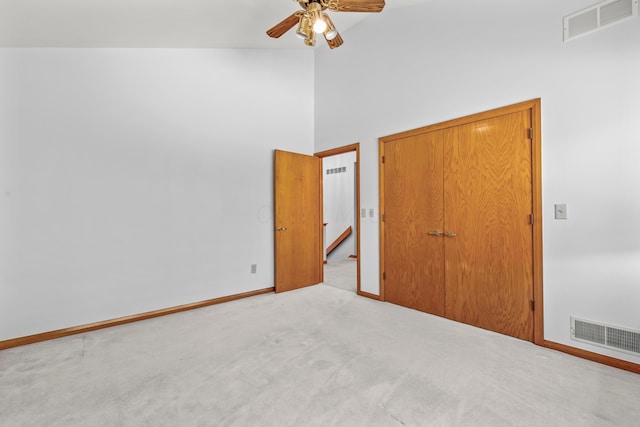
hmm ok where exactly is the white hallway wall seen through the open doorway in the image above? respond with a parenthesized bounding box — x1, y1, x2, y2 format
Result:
(322, 151, 357, 258)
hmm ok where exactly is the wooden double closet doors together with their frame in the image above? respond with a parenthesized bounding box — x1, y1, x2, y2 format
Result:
(380, 99, 544, 344)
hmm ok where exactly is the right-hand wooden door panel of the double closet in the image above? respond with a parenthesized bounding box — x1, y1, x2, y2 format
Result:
(444, 111, 533, 341)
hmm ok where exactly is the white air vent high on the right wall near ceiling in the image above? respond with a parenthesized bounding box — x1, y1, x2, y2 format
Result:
(564, 0, 638, 42)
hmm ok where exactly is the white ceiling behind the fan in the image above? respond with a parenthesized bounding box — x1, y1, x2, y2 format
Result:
(0, 0, 430, 49)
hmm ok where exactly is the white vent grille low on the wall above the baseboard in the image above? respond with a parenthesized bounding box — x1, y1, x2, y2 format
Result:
(571, 317, 640, 354)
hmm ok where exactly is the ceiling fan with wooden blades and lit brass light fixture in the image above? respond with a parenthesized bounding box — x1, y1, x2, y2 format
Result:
(267, 0, 384, 49)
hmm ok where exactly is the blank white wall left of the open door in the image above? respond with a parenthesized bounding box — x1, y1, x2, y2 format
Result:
(0, 49, 314, 340)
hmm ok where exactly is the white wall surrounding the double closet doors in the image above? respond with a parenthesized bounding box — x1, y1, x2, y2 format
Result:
(315, 0, 640, 363)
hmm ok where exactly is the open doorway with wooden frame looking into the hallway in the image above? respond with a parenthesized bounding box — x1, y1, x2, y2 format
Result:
(315, 143, 360, 293)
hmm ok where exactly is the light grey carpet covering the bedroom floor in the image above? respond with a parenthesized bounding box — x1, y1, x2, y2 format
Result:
(0, 285, 640, 427)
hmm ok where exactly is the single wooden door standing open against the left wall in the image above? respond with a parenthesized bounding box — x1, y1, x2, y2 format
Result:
(274, 150, 323, 292)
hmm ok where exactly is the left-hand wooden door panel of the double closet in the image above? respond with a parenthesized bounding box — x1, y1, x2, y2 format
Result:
(383, 131, 444, 316)
